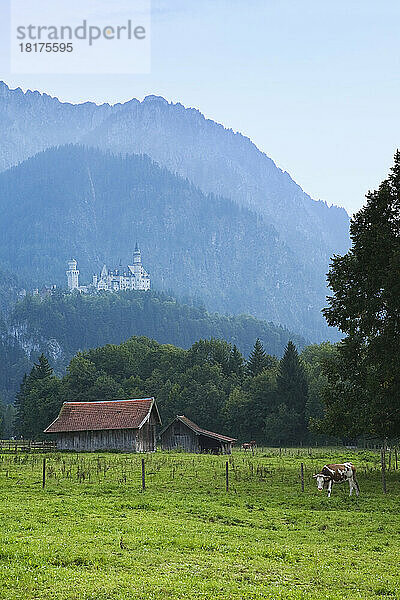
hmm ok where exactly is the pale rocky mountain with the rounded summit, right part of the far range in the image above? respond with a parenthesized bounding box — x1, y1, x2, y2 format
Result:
(83, 96, 348, 260)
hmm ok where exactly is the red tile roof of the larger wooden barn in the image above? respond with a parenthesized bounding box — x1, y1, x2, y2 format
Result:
(44, 398, 161, 433)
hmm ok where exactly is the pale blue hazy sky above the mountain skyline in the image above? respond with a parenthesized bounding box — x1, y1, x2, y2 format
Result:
(3, 0, 400, 212)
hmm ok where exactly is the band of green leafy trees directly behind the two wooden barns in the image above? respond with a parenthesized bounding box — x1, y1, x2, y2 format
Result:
(16, 337, 328, 443)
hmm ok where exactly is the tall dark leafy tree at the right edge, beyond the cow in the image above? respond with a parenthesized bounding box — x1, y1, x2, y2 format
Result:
(324, 151, 400, 437)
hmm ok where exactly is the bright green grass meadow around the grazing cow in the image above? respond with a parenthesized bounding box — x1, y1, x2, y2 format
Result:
(0, 449, 400, 600)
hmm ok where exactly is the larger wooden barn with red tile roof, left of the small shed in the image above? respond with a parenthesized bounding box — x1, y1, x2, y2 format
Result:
(44, 398, 161, 452)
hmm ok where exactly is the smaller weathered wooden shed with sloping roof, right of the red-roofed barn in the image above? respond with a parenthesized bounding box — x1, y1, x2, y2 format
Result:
(159, 415, 236, 454)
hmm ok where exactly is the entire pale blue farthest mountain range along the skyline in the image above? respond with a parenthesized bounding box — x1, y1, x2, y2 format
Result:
(0, 83, 349, 266)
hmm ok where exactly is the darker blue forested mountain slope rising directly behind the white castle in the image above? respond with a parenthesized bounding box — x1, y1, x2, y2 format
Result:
(0, 146, 328, 339)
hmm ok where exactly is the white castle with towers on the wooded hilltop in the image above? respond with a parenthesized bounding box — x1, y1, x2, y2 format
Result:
(66, 244, 150, 292)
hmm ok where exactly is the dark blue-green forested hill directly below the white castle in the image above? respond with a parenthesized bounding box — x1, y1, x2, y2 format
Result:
(10, 291, 305, 371)
